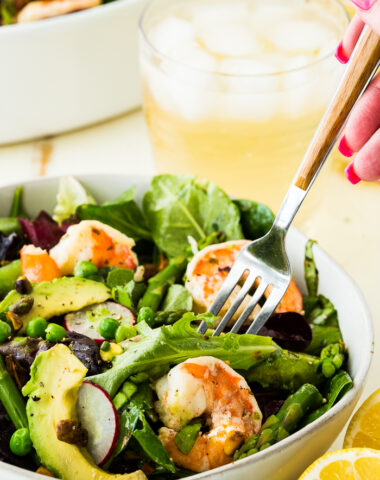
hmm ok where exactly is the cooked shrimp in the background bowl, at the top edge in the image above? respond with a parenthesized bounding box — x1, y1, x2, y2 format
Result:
(17, 0, 101, 23)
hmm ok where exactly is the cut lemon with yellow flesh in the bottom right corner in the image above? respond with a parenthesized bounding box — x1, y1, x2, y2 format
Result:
(298, 448, 380, 480)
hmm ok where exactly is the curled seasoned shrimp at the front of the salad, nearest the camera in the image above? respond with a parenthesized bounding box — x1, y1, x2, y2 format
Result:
(155, 357, 262, 472)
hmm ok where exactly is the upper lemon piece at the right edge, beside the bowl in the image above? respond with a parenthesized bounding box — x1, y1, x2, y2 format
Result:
(343, 388, 380, 450)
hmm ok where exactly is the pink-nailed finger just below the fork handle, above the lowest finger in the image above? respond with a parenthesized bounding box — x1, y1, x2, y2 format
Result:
(338, 75, 380, 157)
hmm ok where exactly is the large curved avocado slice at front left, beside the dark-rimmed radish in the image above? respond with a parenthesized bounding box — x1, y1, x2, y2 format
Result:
(22, 344, 146, 480)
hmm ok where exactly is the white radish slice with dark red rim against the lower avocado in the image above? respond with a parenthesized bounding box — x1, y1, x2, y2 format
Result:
(77, 382, 120, 465)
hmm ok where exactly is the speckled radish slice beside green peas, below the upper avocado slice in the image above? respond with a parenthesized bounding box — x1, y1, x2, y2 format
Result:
(64, 302, 136, 345)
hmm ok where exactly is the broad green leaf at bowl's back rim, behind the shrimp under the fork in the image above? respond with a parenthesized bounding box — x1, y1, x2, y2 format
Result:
(143, 175, 243, 257)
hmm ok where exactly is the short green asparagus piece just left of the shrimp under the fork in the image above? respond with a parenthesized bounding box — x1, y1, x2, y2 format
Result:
(139, 257, 187, 311)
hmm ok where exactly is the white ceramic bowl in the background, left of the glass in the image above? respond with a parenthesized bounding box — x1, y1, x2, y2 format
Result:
(0, 0, 146, 144)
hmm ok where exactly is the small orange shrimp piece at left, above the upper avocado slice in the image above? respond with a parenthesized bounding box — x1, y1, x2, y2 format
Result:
(20, 245, 62, 283)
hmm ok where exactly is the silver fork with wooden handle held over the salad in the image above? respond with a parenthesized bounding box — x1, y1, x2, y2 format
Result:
(198, 27, 380, 336)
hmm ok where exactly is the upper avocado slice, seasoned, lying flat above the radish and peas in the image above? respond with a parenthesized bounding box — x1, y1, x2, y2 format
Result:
(0, 277, 111, 333)
